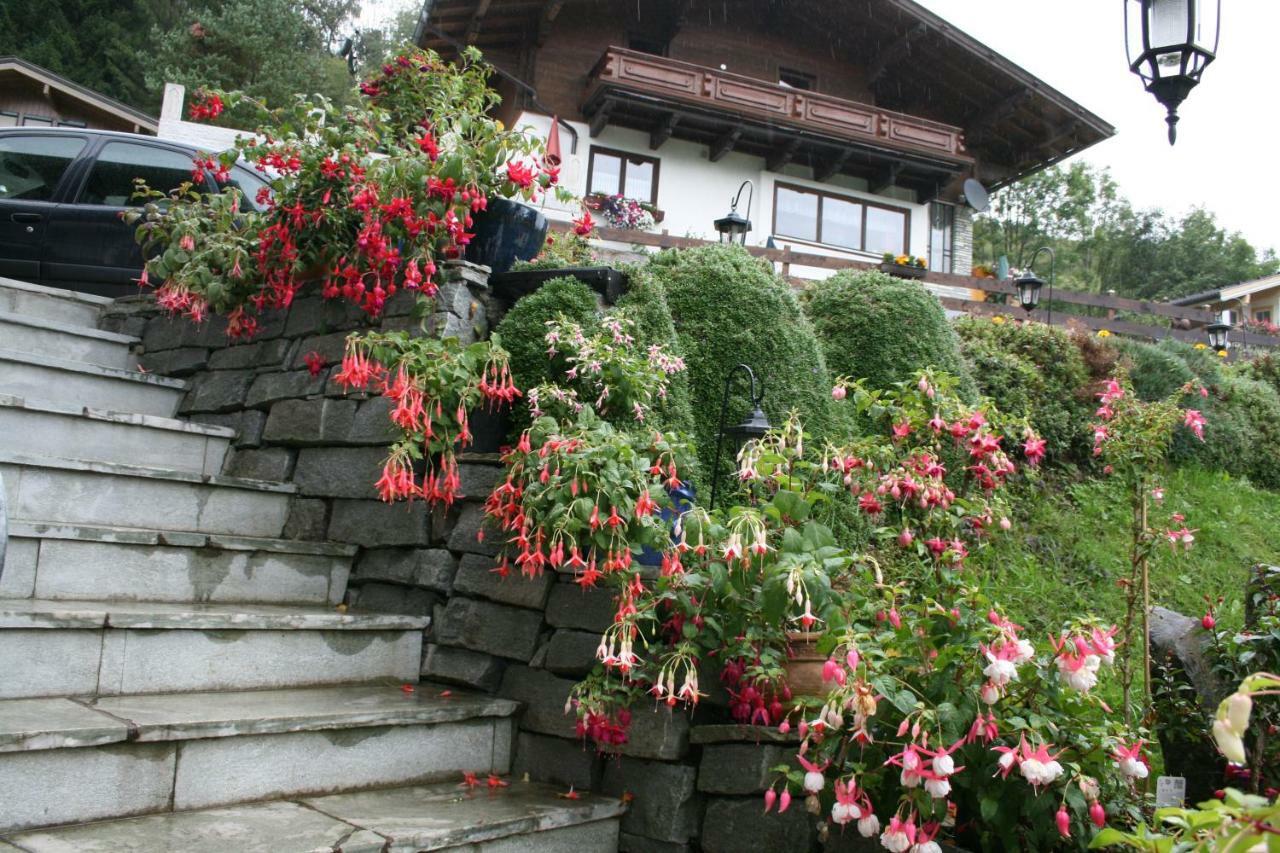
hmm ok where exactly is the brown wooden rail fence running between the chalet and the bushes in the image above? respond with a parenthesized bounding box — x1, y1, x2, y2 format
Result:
(552, 222, 1280, 347)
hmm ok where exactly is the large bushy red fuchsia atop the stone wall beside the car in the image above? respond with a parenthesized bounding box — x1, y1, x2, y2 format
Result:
(128, 49, 558, 336)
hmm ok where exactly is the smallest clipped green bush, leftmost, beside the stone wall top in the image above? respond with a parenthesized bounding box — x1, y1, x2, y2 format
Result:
(495, 277, 598, 402)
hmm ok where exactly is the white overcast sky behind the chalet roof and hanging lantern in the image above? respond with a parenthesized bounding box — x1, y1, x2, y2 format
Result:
(361, 0, 1280, 251)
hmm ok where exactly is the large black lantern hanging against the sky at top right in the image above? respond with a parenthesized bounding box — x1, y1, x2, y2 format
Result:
(1125, 0, 1222, 145)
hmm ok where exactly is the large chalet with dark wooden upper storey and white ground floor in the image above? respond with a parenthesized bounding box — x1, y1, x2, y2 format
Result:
(416, 0, 1114, 274)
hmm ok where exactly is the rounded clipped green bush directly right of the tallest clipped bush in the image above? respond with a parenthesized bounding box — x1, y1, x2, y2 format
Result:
(805, 270, 975, 397)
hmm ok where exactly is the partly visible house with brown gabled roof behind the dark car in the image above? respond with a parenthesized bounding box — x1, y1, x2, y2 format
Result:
(0, 56, 156, 134)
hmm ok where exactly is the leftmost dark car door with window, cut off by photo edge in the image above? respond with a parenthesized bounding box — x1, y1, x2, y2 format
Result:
(0, 133, 88, 282)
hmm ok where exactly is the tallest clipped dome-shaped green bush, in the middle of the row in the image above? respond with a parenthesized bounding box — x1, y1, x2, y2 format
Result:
(649, 246, 838, 484)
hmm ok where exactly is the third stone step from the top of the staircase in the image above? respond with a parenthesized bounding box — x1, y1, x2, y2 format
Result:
(0, 348, 188, 418)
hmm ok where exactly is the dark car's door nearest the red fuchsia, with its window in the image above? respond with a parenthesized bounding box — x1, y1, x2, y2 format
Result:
(42, 137, 193, 296)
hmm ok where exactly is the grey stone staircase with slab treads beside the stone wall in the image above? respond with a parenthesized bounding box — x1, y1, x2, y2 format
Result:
(0, 279, 622, 853)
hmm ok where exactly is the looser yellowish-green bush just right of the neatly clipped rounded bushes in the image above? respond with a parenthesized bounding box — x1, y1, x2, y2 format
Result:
(955, 318, 1092, 461)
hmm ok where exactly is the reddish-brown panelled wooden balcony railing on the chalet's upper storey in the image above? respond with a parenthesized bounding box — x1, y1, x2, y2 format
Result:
(586, 47, 970, 161)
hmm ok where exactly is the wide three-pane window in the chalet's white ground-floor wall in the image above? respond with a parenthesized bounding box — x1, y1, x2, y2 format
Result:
(773, 183, 910, 255)
